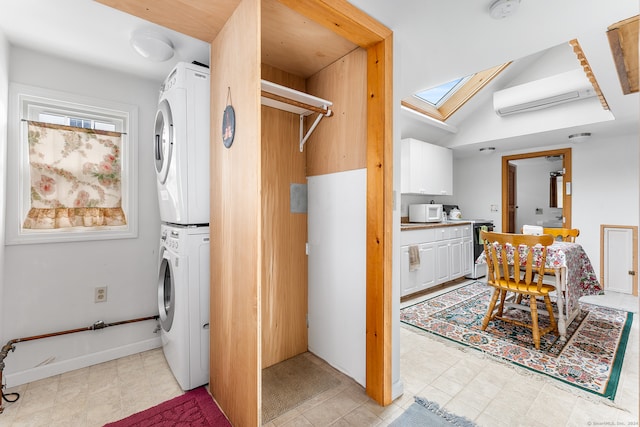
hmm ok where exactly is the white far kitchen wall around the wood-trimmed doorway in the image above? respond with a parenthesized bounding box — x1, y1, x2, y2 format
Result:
(453, 134, 640, 276)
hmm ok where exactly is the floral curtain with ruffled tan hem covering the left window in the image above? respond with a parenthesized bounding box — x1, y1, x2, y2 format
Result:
(23, 121, 127, 229)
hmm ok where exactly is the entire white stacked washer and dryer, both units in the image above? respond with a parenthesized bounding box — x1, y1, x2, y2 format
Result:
(154, 62, 210, 390)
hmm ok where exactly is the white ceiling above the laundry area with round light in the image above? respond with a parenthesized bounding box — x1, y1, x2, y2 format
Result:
(0, 0, 209, 83)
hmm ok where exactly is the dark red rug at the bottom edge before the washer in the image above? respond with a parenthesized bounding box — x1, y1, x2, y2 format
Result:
(105, 387, 231, 427)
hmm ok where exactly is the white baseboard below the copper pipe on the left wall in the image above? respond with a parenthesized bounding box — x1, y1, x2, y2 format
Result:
(4, 337, 162, 388)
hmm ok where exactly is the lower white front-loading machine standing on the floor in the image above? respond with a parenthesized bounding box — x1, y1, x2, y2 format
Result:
(158, 224, 209, 391)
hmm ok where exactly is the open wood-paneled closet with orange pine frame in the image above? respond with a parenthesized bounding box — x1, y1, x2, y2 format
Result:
(99, 0, 393, 426)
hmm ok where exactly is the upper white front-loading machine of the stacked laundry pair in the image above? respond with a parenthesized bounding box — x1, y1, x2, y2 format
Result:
(154, 62, 210, 225)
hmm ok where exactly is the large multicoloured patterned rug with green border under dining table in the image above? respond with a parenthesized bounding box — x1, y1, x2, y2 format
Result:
(400, 282, 633, 400)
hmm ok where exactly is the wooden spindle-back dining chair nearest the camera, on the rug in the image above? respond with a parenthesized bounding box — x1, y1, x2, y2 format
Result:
(480, 231, 558, 349)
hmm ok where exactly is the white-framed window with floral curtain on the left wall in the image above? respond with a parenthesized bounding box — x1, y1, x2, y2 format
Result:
(6, 84, 137, 244)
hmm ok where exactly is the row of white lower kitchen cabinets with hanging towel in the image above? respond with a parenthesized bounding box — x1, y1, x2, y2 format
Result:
(400, 225, 473, 296)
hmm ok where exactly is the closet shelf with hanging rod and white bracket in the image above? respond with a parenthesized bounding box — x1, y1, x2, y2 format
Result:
(260, 80, 333, 152)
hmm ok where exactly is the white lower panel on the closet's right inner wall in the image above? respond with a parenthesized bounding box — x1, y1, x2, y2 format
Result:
(307, 169, 367, 386)
